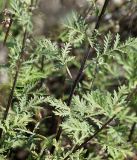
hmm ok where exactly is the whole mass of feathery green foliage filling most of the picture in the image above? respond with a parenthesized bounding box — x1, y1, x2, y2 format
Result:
(0, 0, 137, 160)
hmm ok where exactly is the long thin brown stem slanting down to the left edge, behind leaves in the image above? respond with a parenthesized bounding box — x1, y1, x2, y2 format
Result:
(0, 30, 27, 138)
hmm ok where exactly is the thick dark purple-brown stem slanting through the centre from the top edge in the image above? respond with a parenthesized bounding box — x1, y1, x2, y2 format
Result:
(51, 0, 110, 154)
